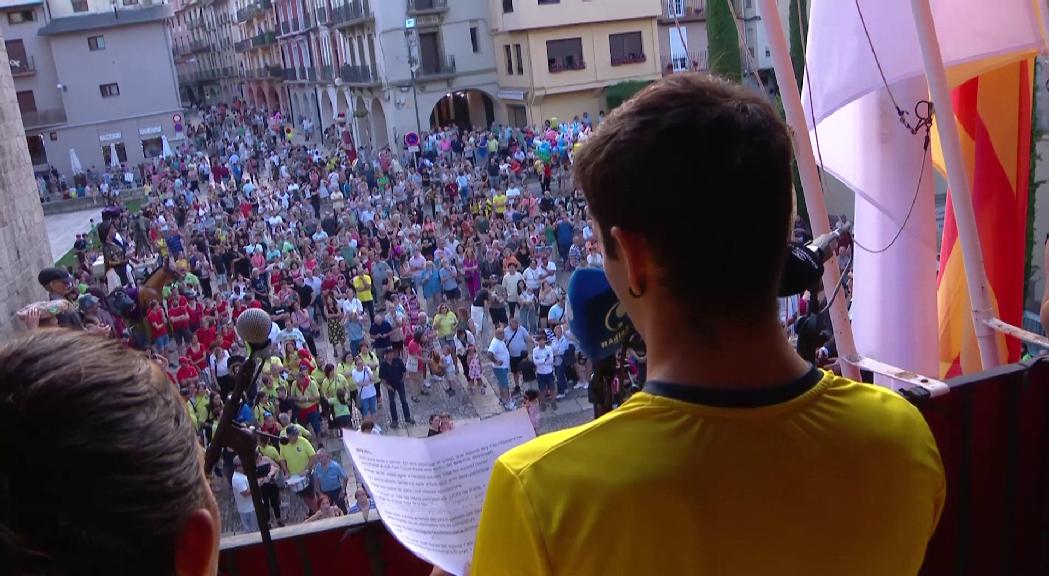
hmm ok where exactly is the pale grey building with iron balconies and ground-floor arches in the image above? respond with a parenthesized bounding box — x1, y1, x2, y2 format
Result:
(268, 0, 499, 148)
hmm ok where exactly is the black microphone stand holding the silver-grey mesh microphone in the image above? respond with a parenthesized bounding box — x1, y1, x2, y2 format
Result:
(204, 341, 280, 576)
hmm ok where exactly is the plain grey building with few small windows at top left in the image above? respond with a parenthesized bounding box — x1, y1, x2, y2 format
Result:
(0, 0, 181, 175)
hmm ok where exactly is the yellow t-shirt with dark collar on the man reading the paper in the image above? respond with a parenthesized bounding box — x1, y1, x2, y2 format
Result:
(471, 372, 946, 576)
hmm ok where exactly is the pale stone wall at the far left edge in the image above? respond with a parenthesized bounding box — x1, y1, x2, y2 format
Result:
(0, 28, 52, 339)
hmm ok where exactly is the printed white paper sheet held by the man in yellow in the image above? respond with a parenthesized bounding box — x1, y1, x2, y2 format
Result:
(343, 410, 535, 574)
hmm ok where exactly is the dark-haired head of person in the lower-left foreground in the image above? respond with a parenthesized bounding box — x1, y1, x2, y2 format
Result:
(0, 329, 220, 576)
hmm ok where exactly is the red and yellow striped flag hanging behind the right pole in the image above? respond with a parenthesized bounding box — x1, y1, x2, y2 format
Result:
(933, 59, 1034, 378)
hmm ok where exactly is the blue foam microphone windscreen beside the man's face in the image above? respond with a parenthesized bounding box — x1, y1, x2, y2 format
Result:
(569, 269, 634, 360)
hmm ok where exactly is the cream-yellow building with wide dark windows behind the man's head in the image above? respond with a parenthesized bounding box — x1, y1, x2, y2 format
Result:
(490, 0, 663, 126)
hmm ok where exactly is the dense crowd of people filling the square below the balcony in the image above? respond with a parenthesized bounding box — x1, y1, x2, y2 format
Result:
(22, 101, 616, 530)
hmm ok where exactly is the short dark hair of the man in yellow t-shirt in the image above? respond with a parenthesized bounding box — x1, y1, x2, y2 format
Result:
(575, 73, 793, 327)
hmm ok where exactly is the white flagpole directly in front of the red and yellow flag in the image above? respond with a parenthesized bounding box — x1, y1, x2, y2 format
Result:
(911, 0, 1000, 370)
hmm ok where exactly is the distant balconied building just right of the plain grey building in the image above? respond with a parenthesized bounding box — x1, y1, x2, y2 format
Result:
(168, 0, 240, 105)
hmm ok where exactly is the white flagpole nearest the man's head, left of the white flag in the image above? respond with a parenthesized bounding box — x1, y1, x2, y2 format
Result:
(755, 0, 860, 381)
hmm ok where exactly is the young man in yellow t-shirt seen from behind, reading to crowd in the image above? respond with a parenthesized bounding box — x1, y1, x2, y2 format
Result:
(471, 73, 946, 576)
